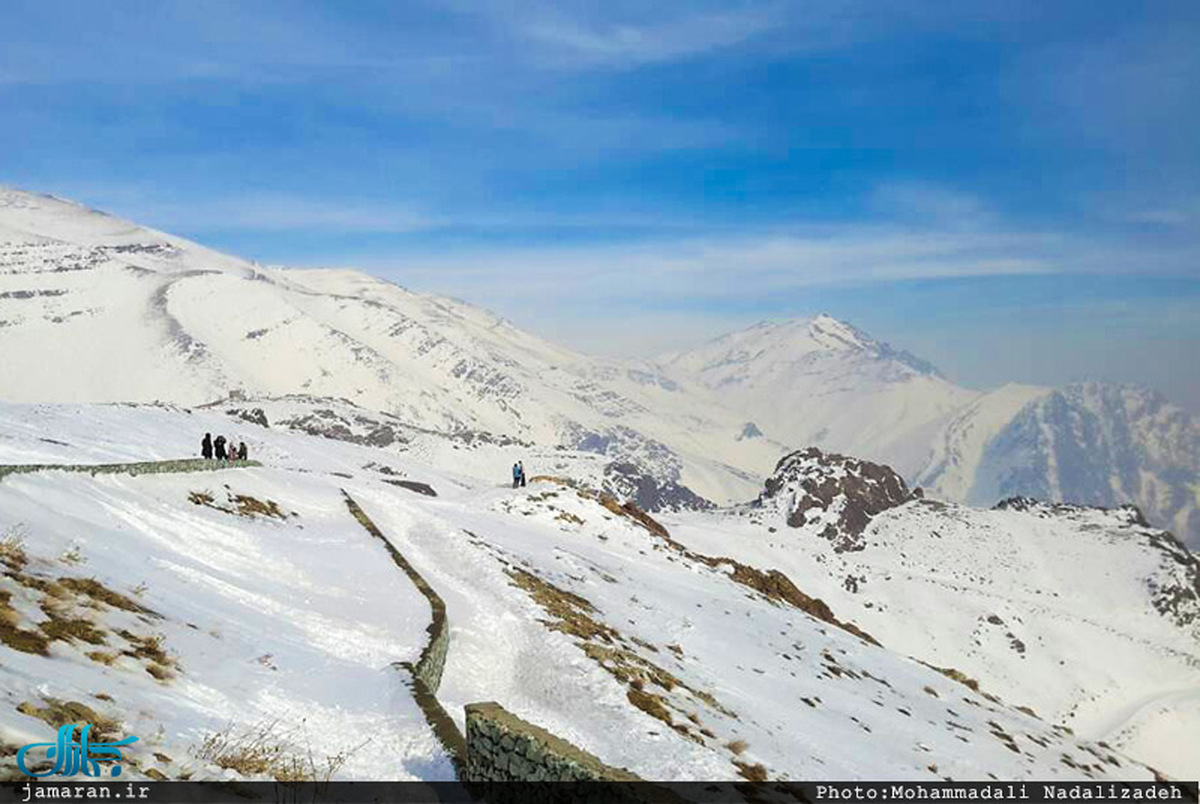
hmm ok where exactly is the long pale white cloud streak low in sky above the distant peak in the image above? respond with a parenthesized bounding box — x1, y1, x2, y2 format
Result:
(360, 226, 1064, 305)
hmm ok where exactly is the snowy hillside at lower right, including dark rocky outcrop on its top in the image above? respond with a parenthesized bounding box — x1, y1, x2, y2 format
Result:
(667, 450, 1200, 776)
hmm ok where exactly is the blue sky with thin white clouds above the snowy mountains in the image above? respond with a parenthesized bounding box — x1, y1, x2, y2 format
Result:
(7, 0, 1200, 409)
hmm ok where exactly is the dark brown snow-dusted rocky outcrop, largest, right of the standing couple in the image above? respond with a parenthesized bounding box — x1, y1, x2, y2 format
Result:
(755, 446, 920, 553)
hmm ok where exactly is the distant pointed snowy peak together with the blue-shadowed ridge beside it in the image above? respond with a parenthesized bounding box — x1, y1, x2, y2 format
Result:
(658, 316, 1200, 545)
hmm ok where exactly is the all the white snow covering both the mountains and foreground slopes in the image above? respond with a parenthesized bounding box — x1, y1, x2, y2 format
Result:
(0, 191, 1200, 780)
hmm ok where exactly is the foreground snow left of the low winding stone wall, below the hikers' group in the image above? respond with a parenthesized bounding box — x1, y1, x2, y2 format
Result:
(0, 453, 450, 779)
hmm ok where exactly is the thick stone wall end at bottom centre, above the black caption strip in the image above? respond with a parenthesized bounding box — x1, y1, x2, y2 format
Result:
(463, 703, 641, 782)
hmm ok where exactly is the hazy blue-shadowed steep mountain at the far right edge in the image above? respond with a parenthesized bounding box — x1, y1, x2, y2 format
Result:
(917, 383, 1200, 542)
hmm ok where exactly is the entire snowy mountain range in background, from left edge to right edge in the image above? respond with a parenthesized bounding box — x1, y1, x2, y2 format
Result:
(0, 190, 1200, 545)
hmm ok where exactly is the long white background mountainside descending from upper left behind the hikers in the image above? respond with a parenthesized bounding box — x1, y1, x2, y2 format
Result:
(0, 190, 785, 500)
